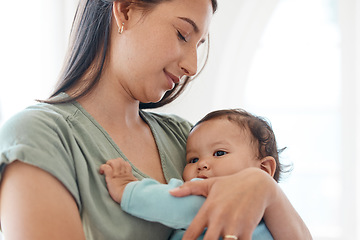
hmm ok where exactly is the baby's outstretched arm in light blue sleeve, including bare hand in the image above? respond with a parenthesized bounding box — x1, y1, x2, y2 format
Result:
(100, 159, 205, 229)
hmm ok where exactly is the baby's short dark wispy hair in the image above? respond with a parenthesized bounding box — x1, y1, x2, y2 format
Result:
(193, 109, 291, 182)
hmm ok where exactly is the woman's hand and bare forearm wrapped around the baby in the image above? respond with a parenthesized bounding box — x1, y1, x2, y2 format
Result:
(172, 168, 312, 240)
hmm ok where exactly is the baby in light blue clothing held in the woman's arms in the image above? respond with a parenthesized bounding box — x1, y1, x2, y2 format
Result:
(100, 109, 282, 240)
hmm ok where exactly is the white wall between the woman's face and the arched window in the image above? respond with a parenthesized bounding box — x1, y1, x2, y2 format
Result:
(156, 0, 278, 122)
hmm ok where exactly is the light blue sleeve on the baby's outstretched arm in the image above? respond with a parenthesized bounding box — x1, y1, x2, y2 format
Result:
(121, 178, 205, 229)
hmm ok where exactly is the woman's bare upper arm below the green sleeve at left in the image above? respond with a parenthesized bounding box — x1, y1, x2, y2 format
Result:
(0, 161, 85, 240)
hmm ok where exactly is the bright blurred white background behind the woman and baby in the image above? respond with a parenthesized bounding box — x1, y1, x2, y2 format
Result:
(0, 0, 360, 240)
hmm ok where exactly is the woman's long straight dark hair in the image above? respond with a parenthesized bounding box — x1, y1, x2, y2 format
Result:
(43, 0, 217, 109)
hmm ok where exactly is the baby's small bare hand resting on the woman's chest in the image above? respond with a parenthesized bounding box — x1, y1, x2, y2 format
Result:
(99, 158, 138, 203)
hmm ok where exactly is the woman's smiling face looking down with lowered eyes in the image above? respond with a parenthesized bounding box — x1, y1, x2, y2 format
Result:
(108, 0, 213, 102)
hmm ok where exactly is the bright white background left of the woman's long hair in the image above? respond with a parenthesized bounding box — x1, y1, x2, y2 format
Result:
(0, 0, 76, 125)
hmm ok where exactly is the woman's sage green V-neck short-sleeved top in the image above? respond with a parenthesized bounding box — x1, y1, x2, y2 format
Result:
(0, 93, 192, 240)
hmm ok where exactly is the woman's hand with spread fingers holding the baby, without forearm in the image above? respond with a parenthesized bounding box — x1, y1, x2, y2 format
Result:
(180, 169, 276, 240)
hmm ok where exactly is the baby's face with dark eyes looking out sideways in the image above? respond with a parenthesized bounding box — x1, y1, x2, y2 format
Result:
(183, 118, 261, 181)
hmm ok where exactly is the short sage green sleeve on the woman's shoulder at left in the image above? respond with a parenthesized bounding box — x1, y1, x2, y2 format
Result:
(0, 106, 80, 207)
